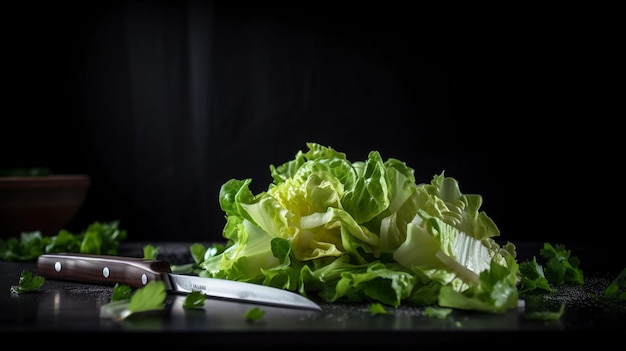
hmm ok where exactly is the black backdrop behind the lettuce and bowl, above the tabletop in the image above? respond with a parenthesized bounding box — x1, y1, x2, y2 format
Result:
(0, 0, 623, 245)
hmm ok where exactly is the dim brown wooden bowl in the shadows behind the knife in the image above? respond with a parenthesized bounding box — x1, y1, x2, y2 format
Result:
(0, 174, 91, 237)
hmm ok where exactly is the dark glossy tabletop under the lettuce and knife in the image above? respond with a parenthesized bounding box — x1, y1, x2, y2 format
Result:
(0, 242, 626, 346)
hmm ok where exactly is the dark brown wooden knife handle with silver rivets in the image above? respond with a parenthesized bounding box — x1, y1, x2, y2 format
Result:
(37, 253, 171, 290)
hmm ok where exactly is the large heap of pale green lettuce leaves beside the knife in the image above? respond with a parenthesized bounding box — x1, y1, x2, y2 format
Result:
(200, 143, 519, 313)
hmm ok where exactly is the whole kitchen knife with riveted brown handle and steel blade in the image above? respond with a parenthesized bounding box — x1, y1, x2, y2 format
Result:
(37, 253, 321, 311)
